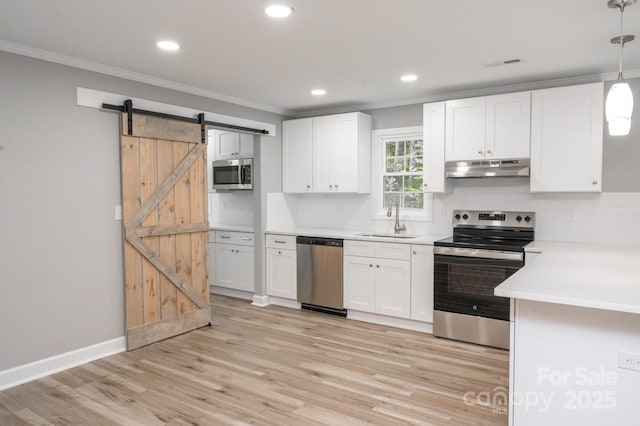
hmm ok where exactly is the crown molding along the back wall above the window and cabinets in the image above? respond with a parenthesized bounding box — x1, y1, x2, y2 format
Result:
(296, 69, 640, 118)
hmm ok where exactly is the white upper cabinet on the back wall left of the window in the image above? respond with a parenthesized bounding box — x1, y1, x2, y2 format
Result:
(282, 112, 371, 193)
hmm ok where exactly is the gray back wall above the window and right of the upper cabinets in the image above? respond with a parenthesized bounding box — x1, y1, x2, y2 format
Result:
(365, 78, 640, 192)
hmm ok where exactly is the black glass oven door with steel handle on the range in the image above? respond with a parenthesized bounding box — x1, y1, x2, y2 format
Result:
(433, 247, 524, 321)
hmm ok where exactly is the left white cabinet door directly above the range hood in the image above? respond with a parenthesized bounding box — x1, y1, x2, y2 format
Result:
(445, 97, 486, 161)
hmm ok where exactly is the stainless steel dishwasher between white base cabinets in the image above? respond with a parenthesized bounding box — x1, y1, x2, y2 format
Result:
(296, 237, 347, 316)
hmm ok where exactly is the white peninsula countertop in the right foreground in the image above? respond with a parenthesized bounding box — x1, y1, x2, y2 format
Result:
(495, 241, 640, 313)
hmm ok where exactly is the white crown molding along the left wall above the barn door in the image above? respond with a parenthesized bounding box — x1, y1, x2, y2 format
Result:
(0, 40, 295, 116)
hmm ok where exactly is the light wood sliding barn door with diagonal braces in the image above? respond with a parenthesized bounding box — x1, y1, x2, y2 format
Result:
(121, 114, 211, 350)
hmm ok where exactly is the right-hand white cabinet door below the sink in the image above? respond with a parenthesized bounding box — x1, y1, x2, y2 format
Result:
(374, 259, 411, 318)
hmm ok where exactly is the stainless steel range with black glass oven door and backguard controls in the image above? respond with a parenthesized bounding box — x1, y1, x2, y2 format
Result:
(433, 210, 535, 349)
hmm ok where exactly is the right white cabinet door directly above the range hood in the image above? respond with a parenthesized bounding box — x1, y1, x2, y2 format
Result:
(485, 92, 531, 160)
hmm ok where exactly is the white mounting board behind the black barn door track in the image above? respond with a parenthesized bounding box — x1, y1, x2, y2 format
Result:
(77, 87, 277, 136)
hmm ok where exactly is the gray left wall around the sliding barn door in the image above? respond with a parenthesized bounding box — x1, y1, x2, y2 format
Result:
(0, 52, 282, 371)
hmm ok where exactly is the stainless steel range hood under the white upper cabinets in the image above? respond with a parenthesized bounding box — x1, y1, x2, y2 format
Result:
(445, 158, 530, 178)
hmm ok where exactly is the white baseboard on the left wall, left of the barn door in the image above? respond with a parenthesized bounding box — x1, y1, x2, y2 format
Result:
(0, 336, 127, 391)
